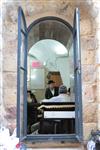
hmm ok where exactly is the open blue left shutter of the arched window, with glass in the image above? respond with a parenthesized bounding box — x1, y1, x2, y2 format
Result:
(17, 7, 27, 139)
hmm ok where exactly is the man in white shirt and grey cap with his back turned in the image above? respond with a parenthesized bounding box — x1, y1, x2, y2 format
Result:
(42, 85, 70, 102)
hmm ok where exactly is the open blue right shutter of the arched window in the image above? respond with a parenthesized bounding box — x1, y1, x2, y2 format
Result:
(73, 8, 82, 141)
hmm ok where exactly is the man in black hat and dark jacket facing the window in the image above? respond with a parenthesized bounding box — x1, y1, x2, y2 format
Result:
(45, 80, 59, 99)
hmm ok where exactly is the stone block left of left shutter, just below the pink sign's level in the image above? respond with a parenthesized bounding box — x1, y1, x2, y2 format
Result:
(3, 72, 17, 89)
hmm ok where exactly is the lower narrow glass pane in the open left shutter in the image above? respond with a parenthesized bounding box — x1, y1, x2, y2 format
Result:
(20, 69, 24, 136)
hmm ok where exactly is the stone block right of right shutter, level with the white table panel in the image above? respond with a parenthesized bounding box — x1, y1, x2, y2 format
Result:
(83, 103, 98, 123)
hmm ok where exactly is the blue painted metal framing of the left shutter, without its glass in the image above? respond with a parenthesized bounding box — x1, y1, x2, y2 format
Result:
(17, 7, 27, 140)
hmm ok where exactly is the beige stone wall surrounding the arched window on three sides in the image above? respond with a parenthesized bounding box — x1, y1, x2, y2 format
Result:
(2, 0, 100, 140)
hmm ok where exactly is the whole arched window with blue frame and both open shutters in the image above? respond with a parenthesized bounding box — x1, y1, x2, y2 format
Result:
(17, 7, 82, 141)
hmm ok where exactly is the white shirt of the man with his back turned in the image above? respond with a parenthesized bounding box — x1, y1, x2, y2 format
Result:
(42, 94, 71, 102)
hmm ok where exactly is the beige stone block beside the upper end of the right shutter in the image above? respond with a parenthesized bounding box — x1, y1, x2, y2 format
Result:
(80, 19, 92, 35)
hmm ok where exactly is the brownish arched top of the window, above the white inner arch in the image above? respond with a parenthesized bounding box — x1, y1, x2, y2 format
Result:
(27, 16, 73, 50)
